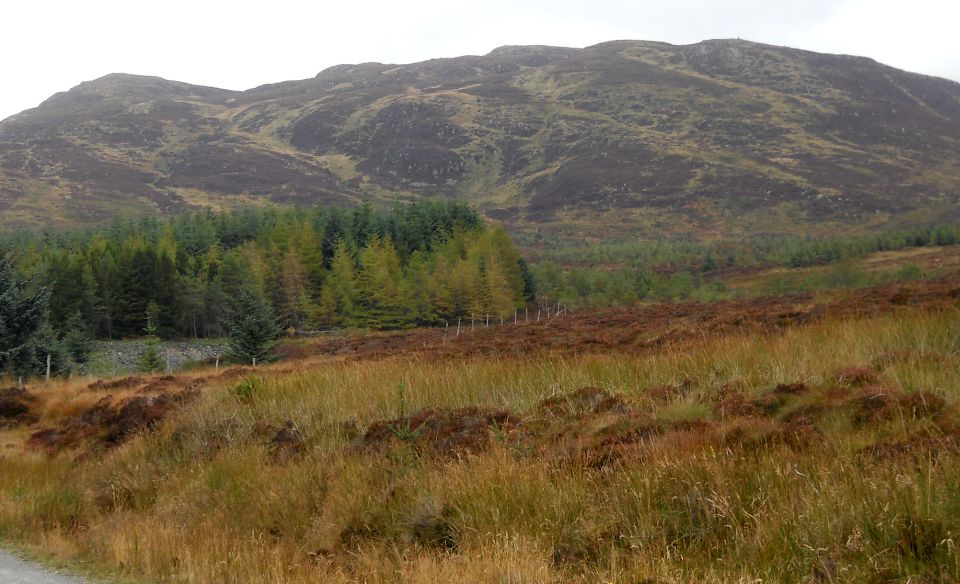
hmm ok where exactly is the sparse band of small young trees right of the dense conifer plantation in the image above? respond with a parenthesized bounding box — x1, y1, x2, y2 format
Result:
(520, 224, 960, 308)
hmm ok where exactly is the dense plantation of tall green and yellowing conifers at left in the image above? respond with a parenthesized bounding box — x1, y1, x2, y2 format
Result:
(0, 201, 535, 374)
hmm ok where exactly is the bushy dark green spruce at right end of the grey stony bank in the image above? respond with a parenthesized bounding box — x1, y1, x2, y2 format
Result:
(227, 287, 280, 363)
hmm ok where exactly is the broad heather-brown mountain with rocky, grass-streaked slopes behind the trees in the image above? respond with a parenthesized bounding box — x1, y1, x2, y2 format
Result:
(0, 40, 960, 240)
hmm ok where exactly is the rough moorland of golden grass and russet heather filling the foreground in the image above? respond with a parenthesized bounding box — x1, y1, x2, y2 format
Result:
(0, 278, 960, 583)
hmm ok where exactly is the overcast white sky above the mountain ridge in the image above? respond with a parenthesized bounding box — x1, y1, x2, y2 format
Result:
(0, 0, 960, 119)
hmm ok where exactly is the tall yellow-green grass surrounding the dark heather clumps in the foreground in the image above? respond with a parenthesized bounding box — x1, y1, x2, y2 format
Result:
(0, 310, 960, 584)
